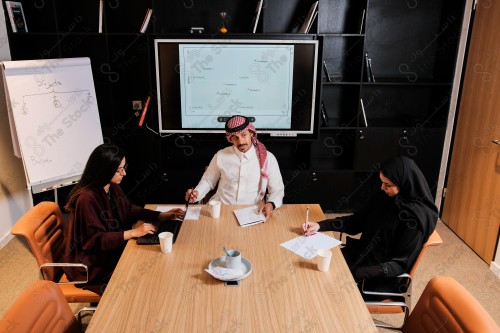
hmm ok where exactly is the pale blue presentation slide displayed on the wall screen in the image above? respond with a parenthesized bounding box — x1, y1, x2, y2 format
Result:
(179, 44, 294, 129)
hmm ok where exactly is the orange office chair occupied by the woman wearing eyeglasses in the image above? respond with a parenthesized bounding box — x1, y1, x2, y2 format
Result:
(10, 201, 101, 310)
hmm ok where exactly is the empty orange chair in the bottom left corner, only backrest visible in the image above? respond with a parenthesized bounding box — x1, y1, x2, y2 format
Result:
(0, 281, 81, 333)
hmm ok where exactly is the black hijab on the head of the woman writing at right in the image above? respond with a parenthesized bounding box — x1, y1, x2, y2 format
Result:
(380, 156, 438, 242)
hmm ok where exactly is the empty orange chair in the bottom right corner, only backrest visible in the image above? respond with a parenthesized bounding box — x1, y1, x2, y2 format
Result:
(402, 276, 500, 333)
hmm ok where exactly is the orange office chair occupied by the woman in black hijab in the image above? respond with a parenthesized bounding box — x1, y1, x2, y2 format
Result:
(361, 230, 443, 329)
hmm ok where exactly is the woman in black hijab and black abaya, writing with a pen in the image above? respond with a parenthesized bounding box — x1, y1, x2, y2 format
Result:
(304, 156, 438, 282)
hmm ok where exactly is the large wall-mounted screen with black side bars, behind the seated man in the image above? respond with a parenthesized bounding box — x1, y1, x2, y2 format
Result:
(155, 39, 318, 136)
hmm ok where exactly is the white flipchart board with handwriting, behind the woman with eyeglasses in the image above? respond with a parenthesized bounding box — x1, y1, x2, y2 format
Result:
(2, 58, 103, 193)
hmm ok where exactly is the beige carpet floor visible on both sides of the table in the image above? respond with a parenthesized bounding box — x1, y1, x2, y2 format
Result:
(0, 222, 500, 332)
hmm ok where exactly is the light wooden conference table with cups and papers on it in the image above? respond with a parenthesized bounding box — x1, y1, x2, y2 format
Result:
(87, 205, 377, 333)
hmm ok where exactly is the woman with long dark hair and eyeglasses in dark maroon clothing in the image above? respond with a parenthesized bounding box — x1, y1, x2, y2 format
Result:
(64, 144, 185, 295)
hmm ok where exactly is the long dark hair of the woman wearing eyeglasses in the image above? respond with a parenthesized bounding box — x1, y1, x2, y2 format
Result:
(64, 144, 125, 212)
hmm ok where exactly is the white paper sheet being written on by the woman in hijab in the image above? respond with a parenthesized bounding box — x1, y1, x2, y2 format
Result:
(280, 232, 342, 259)
